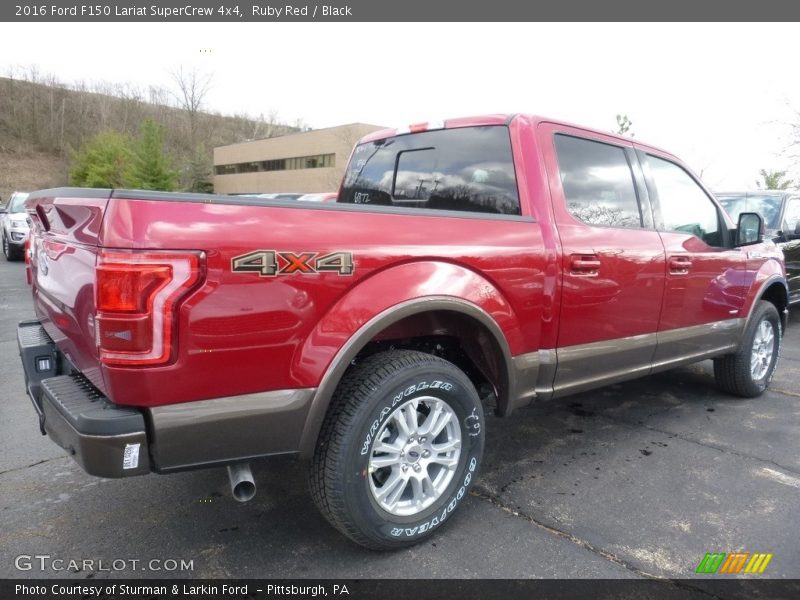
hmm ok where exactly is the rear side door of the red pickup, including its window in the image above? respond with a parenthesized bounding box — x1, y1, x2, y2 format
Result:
(538, 123, 665, 395)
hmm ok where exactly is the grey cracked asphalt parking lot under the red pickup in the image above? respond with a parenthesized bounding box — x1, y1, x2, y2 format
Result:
(0, 259, 800, 578)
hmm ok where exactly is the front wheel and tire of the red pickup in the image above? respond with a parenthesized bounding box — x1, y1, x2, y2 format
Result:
(714, 300, 781, 398)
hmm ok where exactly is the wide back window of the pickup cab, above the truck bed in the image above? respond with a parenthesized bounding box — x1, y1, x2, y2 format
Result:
(338, 126, 520, 215)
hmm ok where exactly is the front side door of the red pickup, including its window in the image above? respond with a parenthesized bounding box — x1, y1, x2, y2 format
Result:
(638, 149, 751, 368)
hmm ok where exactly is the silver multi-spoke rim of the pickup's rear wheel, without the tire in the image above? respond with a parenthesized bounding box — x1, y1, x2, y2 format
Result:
(367, 396, 461, 516)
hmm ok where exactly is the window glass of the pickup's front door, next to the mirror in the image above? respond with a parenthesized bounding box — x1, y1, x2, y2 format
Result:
(647, 155, 722, 246)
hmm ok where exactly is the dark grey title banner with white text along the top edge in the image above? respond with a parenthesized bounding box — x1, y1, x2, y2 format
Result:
(0, 0, 800, 23)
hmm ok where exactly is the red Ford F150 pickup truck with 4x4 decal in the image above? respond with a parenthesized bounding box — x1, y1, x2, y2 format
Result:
(18, 115, 787, 548)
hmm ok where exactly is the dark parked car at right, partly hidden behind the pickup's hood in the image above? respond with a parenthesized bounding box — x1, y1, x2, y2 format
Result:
(717, 190, 800, 304)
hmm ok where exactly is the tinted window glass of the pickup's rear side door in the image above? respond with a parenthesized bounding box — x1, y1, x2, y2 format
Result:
(555, 135, 642, 227)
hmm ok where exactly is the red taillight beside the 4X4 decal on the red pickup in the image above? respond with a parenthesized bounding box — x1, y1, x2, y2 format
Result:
(95, 251, 201, 365)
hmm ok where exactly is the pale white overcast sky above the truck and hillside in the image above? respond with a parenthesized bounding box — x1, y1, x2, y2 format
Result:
(0, 23, 800, 190)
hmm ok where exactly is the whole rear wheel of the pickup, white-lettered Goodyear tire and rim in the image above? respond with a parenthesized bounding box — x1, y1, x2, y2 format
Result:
(309, 350, 484, 550)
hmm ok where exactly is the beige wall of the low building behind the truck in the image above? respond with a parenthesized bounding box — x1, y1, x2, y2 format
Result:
(214, 123, 385, 194)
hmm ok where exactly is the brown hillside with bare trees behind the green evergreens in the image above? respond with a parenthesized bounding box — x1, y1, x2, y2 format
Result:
(0, 71, 298, 202)
